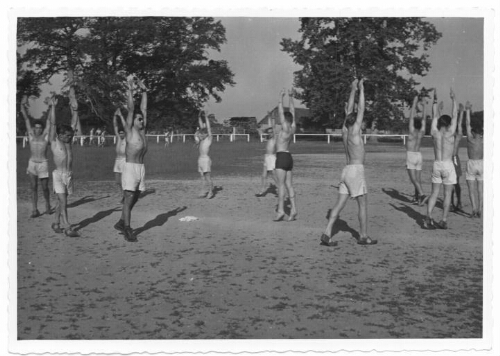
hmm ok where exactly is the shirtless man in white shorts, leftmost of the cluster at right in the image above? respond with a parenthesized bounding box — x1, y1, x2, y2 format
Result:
(406, 95, 428, 205)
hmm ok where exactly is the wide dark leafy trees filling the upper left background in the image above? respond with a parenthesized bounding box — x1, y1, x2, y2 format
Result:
(18, 17, 234, 129)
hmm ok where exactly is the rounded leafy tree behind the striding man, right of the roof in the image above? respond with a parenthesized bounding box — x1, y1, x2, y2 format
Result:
(281, 17, 441, 129)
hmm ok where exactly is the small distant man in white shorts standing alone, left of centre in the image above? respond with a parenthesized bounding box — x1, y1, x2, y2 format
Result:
(194, 110, 214, 199)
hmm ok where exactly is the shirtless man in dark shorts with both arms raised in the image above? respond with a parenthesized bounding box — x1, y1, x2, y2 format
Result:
(274, 89, 297, 221)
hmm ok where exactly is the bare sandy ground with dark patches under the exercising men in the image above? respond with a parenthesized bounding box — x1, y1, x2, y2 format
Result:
(17, 149, 483, 340)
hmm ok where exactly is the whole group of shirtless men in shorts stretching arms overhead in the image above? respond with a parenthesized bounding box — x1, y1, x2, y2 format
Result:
(21, 76, 483, 246)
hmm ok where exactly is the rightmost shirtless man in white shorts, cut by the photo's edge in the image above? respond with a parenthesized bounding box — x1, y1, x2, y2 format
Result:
(465, 102, 483, 218)
